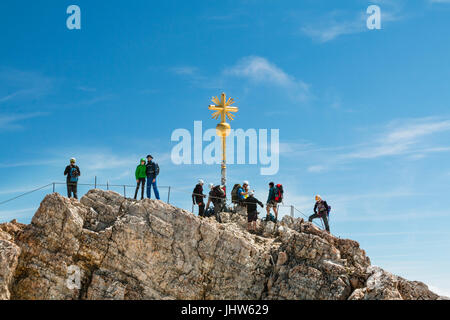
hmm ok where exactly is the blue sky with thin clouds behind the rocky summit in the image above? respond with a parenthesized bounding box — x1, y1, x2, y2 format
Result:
(0, 0, 450, 295)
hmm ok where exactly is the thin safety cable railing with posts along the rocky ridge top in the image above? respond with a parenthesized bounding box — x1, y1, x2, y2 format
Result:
(0, 179, 324, 228)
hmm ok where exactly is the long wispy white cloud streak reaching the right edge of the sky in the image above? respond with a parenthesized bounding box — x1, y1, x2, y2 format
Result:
(280, 117, 450, 173)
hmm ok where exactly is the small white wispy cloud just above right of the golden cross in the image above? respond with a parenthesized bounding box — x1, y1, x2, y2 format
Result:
(224, 56, 310, 100)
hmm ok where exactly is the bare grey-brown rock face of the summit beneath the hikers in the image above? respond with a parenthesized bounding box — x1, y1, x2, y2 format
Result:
(0, 190, 440, 300)
